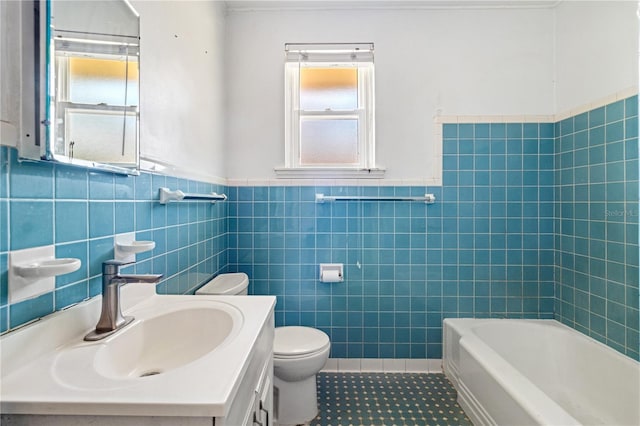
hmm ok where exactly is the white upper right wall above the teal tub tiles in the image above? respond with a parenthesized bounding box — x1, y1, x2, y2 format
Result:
(555, 0, 638, 113)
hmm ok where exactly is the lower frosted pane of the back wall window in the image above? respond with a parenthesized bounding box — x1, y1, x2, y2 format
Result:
(300, 119, 358, 165)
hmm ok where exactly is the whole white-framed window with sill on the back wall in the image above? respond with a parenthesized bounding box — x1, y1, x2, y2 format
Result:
(276, 43, 381, 177)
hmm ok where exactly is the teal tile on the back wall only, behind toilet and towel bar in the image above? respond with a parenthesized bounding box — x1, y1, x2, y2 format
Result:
(229, 124, 554, 358)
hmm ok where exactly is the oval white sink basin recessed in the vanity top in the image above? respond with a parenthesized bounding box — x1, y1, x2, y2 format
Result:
(53, 299, 243, 389)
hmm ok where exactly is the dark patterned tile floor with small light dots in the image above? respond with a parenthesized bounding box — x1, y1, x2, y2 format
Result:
(310, 373, 472, 426)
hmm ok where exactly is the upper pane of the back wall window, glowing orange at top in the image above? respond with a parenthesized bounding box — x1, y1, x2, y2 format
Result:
(300, 67, 358, 111)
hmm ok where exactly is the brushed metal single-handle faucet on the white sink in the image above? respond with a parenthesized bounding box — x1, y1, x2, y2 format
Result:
(84, 260, 162, 341)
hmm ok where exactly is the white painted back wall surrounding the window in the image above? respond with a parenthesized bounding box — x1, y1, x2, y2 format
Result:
(226, 5, 553, 181)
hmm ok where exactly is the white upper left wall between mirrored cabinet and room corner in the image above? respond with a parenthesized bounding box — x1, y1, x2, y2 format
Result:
(132, 0, 227, 182)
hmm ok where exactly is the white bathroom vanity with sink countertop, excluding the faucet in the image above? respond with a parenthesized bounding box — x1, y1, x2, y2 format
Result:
(0, 284, 275, 426)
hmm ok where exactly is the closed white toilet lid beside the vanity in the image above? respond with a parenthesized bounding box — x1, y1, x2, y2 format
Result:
(273, 326, 329, 356)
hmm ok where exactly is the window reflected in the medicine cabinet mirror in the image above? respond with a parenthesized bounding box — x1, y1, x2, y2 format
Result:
(51, 37, 139, 165)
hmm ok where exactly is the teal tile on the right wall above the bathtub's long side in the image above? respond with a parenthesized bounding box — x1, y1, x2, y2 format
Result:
(555, 96, 640, 359)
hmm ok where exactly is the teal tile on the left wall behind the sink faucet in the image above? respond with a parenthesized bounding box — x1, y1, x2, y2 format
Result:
(0, 146, 227, 332)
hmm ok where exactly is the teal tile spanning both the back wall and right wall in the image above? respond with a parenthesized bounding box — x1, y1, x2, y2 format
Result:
(229, 96, 640, 359)
